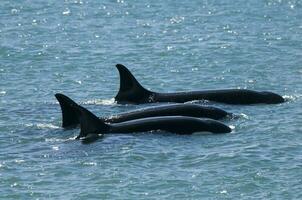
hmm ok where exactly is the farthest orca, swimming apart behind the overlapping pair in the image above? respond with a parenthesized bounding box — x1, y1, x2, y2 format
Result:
(115, 64, 285, 105)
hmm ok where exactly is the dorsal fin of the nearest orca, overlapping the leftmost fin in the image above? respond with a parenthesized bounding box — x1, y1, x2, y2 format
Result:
(75, 102, 110, 139)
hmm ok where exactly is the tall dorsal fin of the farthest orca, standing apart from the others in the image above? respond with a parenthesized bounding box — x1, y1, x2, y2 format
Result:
(115, 64, 152, 103)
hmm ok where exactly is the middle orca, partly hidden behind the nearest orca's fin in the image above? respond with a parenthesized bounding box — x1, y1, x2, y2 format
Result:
(55, 93, 232, 128)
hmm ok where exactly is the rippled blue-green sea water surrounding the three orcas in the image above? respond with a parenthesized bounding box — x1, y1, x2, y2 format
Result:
(0, 0, 302, 199)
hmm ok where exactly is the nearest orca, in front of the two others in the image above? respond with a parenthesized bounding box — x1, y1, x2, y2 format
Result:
(66, 98, 231, 140)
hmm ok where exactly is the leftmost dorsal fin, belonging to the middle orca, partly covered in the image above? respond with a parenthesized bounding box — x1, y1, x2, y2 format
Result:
(55, 93, 80, 128)
